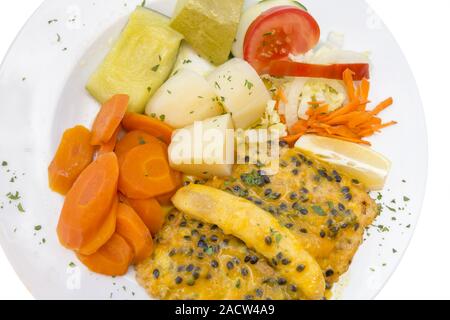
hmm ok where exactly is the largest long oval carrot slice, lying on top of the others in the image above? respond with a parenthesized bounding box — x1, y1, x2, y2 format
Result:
(57, 152, 119, 254)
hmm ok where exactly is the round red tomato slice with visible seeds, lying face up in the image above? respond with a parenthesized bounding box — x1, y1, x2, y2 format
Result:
(244, 6, 320, 74)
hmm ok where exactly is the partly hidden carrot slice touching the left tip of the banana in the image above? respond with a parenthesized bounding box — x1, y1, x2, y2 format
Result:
(126, 198, 165, 235)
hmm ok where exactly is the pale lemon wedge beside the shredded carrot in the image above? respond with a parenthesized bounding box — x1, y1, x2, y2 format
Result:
(295, 135, 391, 191)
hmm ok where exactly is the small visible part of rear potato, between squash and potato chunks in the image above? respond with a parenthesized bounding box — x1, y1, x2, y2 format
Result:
(172, 42, 216, 77)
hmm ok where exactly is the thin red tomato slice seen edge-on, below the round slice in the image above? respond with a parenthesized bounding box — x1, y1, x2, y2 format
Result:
(268, 61, 370, 81)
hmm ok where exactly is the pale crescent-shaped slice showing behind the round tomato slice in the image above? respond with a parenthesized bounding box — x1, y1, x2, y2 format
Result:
(233, 0, 307, 59)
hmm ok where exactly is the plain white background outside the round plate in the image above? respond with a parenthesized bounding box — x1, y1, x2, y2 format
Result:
(0, 0, 450, 299)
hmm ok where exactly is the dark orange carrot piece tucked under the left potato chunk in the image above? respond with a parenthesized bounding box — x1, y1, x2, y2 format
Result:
(122, 113, 174, 144)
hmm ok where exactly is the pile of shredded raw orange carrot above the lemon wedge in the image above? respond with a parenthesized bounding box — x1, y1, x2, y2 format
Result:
(283, 70, 397, 145)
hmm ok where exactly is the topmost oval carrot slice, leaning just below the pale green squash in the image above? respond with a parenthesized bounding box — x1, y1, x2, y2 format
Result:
(91, 94, 130, 146)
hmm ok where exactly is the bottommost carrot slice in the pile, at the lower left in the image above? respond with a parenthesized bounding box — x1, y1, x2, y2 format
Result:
(77, 233, 134, 276)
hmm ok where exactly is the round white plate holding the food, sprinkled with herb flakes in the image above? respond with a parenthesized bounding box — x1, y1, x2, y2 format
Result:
(0, 0, 427, 299)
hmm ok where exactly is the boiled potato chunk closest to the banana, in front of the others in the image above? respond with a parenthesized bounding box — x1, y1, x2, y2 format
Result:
(169, 114, 234, 178)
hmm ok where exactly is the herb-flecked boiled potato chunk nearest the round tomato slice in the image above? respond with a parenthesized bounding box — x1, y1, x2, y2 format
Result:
(208, 58, 270, 129)
